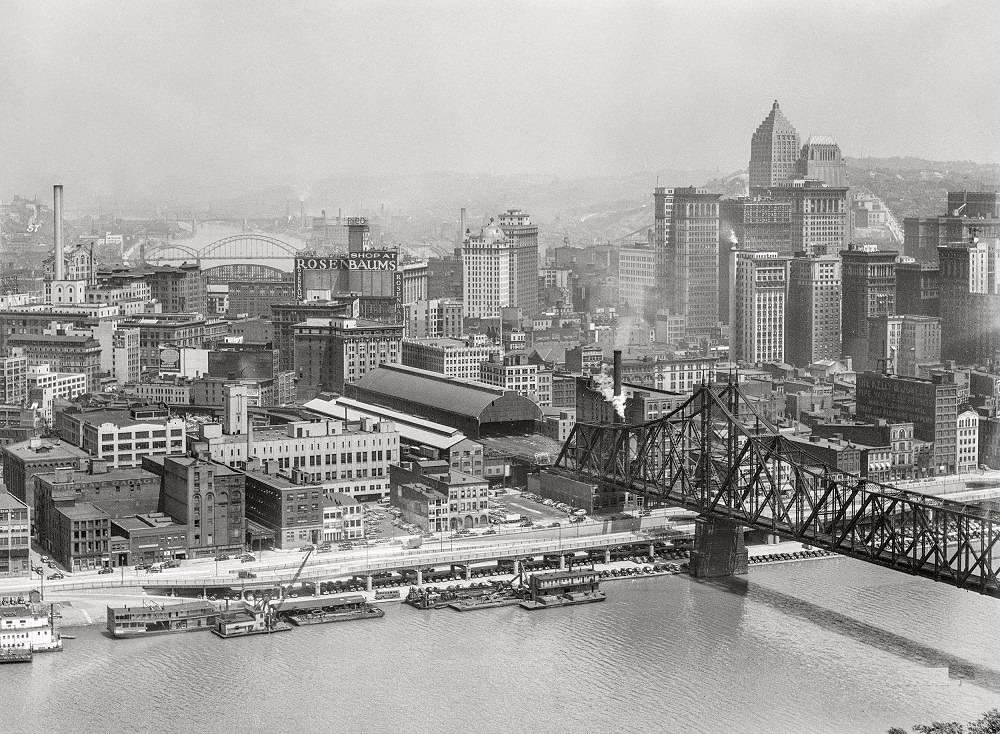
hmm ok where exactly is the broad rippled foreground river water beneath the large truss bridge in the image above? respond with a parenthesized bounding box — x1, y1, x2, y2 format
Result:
(0, 558, 1000, 734)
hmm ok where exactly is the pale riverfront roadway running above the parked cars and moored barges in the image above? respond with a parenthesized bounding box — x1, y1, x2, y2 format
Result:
(9, 529, 662, 594)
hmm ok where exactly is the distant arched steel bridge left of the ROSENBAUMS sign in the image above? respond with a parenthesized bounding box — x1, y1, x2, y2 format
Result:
(144, 232, 301, 282)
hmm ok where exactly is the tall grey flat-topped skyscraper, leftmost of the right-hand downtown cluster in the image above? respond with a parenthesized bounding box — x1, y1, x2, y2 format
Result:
(653, 187, 720, 335)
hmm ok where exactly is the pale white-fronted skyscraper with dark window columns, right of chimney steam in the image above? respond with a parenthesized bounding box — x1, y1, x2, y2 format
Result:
(731, 252, 788, 364)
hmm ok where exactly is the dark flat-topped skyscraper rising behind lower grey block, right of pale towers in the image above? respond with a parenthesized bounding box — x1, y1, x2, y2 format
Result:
(840, 244, 899, 372)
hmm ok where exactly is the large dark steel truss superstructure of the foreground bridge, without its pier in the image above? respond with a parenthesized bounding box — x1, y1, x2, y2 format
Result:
(553, 385, 1000, 597)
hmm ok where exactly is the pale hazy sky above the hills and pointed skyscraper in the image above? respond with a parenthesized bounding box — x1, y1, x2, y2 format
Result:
(0, 0, 1000, 198)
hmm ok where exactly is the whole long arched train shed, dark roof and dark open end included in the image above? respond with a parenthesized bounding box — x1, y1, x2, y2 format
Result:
(344, 364, 542, 438)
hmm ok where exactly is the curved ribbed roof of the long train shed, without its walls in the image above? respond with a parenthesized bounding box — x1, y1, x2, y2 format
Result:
(351, 364, 541, 420)
